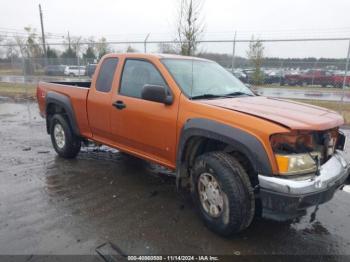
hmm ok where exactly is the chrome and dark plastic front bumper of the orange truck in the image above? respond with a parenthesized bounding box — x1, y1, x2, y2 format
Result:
(259, 150, 350, 221)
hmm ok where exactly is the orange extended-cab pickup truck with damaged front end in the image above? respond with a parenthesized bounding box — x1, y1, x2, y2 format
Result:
(37, 54, 349, 235)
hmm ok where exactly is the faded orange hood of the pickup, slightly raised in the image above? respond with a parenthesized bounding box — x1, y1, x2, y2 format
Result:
(200, 96, 344, 130)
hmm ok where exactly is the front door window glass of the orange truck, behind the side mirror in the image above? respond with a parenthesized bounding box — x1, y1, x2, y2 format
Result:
(120, 59, 167, 98)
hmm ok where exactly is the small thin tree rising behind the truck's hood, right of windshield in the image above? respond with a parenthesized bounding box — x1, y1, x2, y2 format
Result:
(247, 36, 265, 85)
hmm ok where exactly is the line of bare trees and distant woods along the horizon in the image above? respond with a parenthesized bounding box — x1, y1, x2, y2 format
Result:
(0, 0, 345, 83)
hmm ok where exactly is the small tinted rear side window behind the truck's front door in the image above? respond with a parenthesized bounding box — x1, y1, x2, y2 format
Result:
(96, 58, 118, 92)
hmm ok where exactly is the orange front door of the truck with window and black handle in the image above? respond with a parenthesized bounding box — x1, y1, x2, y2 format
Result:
(111, 58, 178, 166)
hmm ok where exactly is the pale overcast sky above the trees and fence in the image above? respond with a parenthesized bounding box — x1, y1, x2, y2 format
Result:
(0, 0, 350, 57)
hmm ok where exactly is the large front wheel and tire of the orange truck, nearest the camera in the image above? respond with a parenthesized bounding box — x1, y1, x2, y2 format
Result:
(192, 152, 255, 236)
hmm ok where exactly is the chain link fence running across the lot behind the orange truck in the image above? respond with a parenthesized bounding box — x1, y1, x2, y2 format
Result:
(0, 39, 350, 88)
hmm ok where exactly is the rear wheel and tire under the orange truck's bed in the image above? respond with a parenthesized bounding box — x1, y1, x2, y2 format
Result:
(50, 114, 81, 158)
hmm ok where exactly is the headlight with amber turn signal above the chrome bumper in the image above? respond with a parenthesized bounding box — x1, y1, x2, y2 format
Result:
(275, 152, 320, 175)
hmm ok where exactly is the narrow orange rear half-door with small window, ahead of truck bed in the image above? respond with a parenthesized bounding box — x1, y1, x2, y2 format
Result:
(87, 57, 118, 142)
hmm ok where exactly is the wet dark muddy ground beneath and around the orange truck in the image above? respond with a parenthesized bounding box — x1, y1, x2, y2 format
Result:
(0, 99, 350, 255)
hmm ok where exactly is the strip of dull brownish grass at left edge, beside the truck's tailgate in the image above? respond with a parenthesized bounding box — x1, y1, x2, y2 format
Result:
(0, 82, 36, 99)
